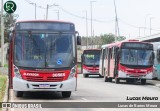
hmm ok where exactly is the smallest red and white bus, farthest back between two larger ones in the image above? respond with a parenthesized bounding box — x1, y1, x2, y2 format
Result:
(81, 49, 101, 77)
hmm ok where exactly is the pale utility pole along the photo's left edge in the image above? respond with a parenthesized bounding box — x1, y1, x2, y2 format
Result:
(1, 0, 4, 67)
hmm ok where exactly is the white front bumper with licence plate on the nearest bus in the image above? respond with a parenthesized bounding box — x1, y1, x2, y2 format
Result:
(13, 77, 77, 91)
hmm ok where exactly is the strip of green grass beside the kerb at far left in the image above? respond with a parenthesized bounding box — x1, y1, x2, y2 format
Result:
(0, 74, 7, 102)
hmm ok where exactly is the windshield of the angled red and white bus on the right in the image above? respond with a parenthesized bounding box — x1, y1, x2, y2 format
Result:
(120, 49, 154, 66)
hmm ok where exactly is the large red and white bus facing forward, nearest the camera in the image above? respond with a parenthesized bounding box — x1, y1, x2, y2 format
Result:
(8, 20, 81, 97)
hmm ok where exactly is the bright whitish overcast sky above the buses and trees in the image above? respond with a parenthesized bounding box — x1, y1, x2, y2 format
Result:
(4, 0, 160, 38)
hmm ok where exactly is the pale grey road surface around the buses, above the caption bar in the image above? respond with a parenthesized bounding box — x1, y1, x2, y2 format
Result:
(11, 74, 160, 102)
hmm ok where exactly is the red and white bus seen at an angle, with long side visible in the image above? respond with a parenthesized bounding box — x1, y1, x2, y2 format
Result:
(99, 40, 154, 84)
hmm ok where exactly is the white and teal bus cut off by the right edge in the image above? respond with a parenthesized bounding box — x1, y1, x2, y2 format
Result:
(152, 42, 160, 80)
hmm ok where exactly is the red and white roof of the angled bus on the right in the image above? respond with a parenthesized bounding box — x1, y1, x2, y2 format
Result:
(101, 39, 148, 49)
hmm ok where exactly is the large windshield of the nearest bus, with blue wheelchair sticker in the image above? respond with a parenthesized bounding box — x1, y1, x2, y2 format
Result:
(14, 31, 75, 68)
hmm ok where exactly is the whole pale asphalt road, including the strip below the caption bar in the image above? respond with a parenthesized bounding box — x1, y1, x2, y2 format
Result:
(5, 74, 160, 111)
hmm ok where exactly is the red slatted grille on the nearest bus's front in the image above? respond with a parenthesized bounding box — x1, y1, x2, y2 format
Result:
(26, 76, 63, 82)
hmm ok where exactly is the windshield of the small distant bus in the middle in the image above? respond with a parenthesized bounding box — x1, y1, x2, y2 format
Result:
(83, 50, 100, 65)
